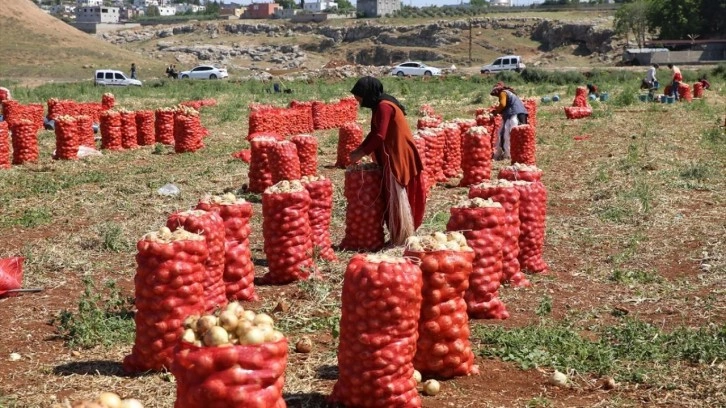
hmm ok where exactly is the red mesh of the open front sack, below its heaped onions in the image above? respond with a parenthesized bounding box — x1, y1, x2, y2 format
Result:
(171, 338, 288, 408)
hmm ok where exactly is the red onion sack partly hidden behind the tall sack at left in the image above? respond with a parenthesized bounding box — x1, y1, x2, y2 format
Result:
(166, 210, 227, 311)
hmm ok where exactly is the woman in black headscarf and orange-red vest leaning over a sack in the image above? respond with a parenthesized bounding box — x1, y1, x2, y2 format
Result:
(350, 76, 426, 245)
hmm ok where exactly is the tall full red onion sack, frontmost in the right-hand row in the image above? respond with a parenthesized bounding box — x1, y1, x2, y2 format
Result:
(330, 254, 422, 408)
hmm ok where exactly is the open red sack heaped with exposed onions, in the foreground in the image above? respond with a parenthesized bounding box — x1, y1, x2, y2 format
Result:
(171, 302, 287, 408)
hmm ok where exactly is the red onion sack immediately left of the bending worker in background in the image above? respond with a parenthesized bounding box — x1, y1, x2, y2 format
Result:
(459, 126, 492, 187)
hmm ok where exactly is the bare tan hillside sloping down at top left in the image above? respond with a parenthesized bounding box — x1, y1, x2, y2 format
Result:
(0, 0, 163, 83)
